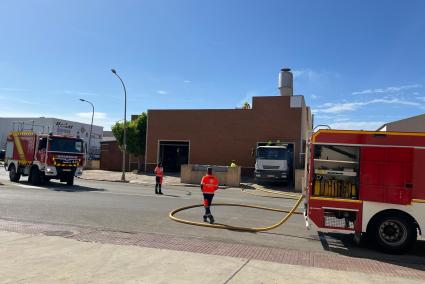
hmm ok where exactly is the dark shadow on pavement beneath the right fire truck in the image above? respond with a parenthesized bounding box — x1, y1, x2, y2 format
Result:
(318, 232, 425, 271)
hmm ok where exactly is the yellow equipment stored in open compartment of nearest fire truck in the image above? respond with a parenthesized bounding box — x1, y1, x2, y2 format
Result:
(313, 175, 357, 198)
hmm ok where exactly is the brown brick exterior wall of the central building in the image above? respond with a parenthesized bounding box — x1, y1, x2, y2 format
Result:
(146, 96, 311, 174)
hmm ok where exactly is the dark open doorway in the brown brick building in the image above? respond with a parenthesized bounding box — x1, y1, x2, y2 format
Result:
(158, 141, 189, 172)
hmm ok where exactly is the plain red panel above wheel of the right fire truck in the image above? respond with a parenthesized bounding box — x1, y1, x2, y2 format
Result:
(360, 147, 413, 204)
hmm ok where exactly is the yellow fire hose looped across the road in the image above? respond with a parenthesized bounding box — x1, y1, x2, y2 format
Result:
(169, 189, 304, 232)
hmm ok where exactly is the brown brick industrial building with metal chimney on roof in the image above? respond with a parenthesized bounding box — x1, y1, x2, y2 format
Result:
(145, 69, 312, 175)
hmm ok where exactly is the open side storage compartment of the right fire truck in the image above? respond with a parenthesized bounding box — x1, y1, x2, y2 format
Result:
(310, 144, 361, 230)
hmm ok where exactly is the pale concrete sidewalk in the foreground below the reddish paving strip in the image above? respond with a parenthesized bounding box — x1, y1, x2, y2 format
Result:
(0, 231, 423, 284)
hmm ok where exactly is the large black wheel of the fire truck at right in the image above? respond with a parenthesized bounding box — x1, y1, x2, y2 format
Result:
(368, 213, 418, 254)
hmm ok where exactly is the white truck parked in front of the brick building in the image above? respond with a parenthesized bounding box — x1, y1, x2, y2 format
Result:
(255, 145, 292, 183)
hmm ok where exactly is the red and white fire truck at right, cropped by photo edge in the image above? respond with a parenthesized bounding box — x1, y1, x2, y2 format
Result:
(306, 129, 425, 253)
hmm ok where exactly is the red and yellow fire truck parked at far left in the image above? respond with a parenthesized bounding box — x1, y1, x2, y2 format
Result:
(4, 131, 85, 185)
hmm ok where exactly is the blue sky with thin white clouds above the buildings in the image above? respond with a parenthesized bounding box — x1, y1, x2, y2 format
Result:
(0, 0, 425, 129)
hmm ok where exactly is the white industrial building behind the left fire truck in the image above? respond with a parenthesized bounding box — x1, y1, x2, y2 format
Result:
(0, 117, 103, 157)
